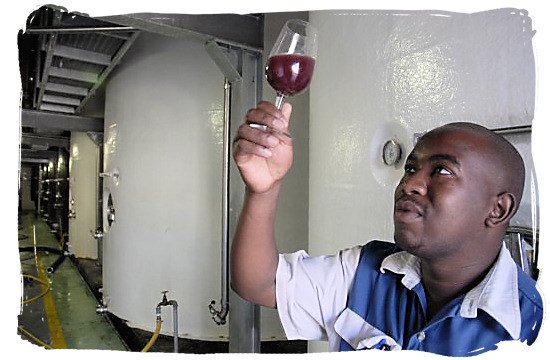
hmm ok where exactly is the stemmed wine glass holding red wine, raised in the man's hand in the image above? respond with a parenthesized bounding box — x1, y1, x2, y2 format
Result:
(250, 19, 317, 137)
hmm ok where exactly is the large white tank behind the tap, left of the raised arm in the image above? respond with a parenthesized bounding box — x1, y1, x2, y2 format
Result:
(103, 33, 281, 341)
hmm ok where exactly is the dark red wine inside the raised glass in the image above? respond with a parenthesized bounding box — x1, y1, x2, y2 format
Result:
(265, 54, 315, 96)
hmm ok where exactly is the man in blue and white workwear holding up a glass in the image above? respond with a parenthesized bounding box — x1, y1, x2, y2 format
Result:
(231, 102, 543, 356)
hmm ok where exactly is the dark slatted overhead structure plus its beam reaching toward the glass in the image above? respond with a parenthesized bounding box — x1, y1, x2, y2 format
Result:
(18, 5, 262, 162)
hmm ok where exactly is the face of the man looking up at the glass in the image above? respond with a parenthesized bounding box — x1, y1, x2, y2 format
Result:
(394, 130, 498, 260)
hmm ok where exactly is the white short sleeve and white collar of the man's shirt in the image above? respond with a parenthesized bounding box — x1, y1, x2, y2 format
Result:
(276, 240, 521, 351)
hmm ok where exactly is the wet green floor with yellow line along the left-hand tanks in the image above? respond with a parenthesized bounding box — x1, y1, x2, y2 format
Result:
(19, 213, 128, 351)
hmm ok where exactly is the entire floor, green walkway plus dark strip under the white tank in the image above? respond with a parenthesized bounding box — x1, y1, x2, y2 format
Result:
(19, 212, 307, 354)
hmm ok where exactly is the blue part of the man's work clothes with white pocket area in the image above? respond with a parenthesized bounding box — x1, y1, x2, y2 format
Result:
(337, 241, 542, 356)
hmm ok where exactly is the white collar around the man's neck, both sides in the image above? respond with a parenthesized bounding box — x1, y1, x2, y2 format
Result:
(380, 244, 521, 339)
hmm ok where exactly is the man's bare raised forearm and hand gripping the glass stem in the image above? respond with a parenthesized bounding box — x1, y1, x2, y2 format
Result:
(230, 102, 293, 308)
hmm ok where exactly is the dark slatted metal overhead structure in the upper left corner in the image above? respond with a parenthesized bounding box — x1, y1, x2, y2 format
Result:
(18, 5, 139, 162)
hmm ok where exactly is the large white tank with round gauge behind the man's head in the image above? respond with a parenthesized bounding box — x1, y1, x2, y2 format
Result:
(309, 9, 535, 351)
